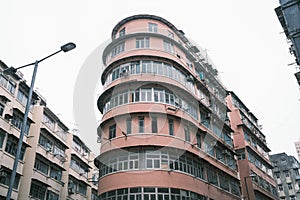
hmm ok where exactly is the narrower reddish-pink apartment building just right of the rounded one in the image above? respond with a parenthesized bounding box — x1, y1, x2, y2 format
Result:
(227, 91, 277, 200)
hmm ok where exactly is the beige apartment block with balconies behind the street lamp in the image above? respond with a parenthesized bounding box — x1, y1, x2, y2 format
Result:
(0, 61, 98, 200)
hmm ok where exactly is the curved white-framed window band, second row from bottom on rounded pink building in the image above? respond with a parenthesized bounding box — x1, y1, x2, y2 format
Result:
(99, 149, 219, 183)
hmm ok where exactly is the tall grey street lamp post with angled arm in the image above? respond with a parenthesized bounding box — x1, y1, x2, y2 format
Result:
(2, 42, 76, 200)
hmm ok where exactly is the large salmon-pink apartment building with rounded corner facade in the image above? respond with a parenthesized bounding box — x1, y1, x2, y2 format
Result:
(95, 15, 241, 200)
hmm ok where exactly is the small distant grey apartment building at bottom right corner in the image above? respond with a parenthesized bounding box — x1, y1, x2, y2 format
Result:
(270, 153, 300, 200)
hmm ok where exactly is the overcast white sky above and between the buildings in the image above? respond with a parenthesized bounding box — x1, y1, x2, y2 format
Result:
(0, 0, 300, 157)
